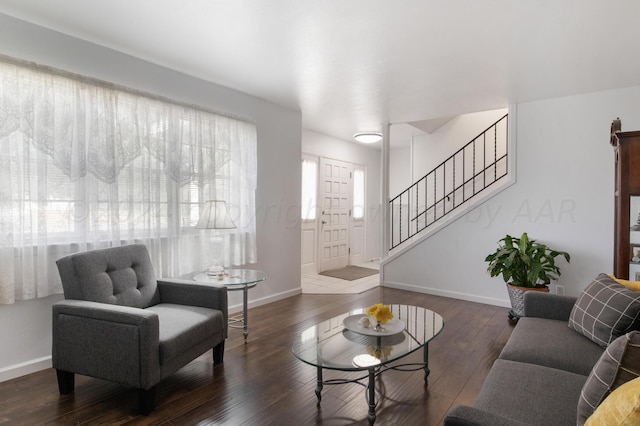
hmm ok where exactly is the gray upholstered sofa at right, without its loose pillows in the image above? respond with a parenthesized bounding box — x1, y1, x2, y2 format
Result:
(444, 292, 604, 426)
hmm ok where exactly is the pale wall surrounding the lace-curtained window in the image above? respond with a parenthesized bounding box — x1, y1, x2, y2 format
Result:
(0, 14, 301, 381)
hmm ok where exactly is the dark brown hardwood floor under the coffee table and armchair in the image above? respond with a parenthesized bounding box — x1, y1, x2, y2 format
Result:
(0, 288, 513, 425)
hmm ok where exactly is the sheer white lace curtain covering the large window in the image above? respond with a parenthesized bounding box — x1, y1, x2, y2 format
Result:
(0, 62, 257, 304)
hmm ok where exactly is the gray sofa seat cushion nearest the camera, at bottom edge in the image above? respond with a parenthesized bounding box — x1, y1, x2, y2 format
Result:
(473, 359, 586, 426)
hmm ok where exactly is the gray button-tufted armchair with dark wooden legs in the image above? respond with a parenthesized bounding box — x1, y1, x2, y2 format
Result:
(52, 244, 228, 415)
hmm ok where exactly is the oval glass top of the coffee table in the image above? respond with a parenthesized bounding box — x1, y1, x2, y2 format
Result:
(292, 305, 444, 371)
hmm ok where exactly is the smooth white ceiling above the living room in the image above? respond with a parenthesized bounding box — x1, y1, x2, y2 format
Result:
(0, 0, 640, 146)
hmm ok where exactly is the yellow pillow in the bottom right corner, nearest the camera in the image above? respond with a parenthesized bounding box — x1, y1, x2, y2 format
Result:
(584, 377, 640, 426)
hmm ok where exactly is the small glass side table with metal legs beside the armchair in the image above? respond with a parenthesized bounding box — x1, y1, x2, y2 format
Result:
(193, 268, 267, 343)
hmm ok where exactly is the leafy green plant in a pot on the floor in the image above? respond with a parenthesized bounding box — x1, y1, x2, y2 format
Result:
(485, 232, 571, 320)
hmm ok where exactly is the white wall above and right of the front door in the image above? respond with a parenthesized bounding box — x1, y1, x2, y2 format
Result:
(298, 130, 382, 260)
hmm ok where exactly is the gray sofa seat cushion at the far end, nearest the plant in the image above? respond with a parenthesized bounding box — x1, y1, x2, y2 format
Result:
(500, 317, 604, 377)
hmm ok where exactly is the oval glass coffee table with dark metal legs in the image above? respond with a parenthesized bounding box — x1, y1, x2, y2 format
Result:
(292, 305, 444, 425)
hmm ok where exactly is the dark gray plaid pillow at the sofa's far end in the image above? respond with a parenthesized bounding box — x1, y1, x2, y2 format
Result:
(569, 274, 640, 347)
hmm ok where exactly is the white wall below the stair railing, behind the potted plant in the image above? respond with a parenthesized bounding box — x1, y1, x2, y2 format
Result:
(383, 87, 640, 306)
